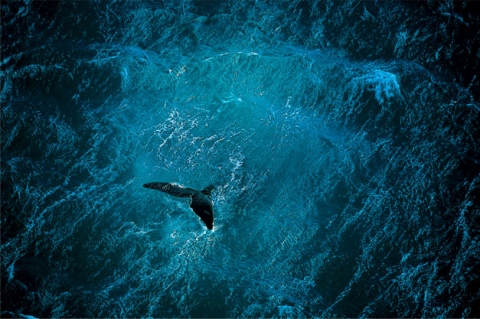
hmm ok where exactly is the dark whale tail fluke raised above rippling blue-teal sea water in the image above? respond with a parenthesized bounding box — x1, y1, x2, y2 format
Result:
(143, 182, 215, 229)
